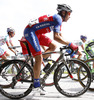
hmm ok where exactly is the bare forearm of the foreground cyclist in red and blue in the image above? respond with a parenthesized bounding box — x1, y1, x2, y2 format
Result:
(54, 32, 69, 45)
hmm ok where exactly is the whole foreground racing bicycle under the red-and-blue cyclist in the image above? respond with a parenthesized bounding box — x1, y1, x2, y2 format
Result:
(0, 43, 91, 99)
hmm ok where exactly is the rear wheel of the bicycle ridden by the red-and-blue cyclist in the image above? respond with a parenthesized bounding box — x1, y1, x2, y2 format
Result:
(0, 60, 34, 99)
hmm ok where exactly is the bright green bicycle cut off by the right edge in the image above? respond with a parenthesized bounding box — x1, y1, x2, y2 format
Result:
(78, 42, 94, 91)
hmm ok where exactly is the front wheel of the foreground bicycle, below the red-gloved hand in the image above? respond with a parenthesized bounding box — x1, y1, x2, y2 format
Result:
(54, 60, 91, 97)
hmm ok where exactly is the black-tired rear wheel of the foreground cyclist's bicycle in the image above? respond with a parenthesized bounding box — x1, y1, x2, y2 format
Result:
(0, 60, 34, 99)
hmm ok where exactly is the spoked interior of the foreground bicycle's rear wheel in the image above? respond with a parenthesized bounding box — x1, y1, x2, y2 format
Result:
(0, 61, 33, 98)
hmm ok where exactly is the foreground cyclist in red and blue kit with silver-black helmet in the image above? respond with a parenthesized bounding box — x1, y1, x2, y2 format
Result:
(24, 4, 78, 95)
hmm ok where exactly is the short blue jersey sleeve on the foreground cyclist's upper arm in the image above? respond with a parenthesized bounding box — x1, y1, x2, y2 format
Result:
(53, 14, 62, 33)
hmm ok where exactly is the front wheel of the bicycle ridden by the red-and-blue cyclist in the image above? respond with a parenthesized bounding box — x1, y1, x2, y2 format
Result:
(54, 59, 91, 97)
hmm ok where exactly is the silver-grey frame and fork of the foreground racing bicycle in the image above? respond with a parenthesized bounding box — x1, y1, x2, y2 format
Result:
(10, 42, 73, 85)
